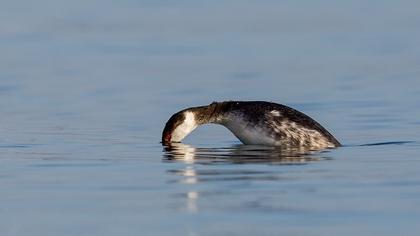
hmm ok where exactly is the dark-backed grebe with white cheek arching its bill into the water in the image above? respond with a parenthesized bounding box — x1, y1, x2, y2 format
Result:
(162, 101, 340, 149)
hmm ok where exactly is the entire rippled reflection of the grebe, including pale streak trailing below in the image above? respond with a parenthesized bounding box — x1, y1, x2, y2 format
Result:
(163, 143, 332, 213)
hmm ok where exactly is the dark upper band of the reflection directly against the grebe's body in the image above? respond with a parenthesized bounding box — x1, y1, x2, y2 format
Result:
(163, 143, 328, 164)
